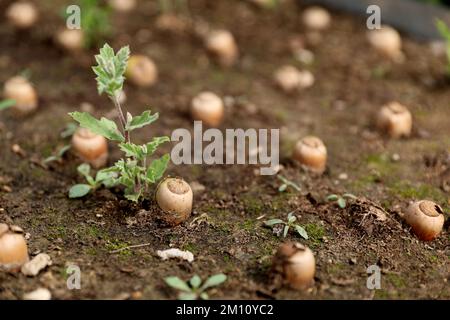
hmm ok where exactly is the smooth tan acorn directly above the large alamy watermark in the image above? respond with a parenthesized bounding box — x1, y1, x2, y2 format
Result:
(191, 92, 224, 127)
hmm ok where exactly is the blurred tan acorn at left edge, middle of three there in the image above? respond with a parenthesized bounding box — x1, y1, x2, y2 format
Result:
(3, 76, 38, 115)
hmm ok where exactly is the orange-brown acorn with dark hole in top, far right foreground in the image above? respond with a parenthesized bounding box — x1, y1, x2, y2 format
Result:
(404, 200, 445, 241)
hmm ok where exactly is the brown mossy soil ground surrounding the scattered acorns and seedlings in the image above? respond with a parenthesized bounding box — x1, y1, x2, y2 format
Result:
(0, 0, 450, 299)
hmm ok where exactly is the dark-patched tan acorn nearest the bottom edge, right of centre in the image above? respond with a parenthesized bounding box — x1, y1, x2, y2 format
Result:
(272, 242, 316, 290)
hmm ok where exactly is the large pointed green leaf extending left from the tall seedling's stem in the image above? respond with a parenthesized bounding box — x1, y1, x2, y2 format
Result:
(69, 111, 125, 142)
